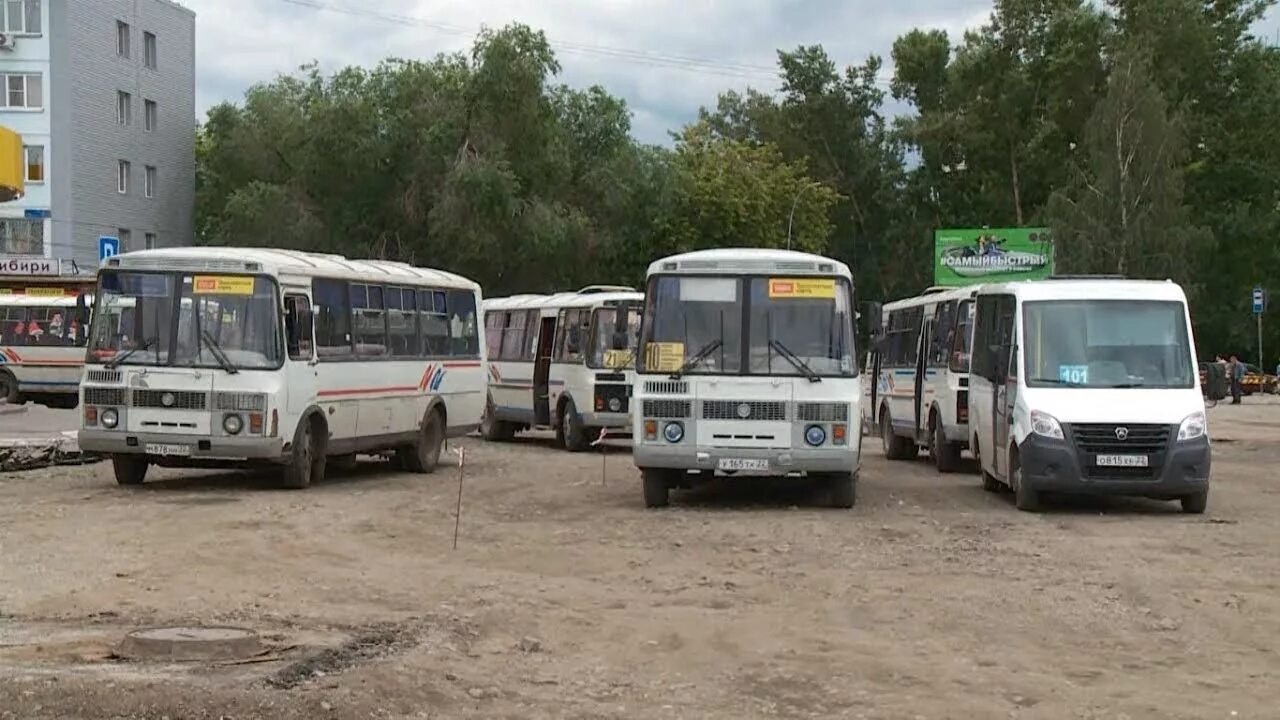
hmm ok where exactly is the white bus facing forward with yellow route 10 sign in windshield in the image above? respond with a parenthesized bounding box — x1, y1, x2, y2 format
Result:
(631, 249, 861, 507)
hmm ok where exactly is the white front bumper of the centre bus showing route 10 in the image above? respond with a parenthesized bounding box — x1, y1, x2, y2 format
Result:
(632, 442, 858, 475)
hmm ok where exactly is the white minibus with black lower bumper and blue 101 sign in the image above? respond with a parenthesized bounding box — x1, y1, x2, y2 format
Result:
(969, 272, 1210, 512)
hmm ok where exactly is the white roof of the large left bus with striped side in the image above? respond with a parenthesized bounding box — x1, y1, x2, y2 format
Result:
(102, 247, 480, 290)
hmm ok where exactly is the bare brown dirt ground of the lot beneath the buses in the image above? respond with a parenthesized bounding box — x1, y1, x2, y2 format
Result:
(0, 398, 1280, 720)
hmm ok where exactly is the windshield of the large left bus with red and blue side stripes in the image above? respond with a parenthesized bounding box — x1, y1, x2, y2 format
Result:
(88, 272, 282, 370)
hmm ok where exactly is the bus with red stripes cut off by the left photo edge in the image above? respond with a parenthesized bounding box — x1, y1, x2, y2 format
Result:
(0, 263, 93, 407)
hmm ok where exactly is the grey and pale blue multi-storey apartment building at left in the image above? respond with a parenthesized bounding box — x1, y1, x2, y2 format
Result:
(0, 0, 196, 270)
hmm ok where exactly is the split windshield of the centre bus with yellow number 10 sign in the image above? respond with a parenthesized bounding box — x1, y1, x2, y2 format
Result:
(640, 275, 858, 378)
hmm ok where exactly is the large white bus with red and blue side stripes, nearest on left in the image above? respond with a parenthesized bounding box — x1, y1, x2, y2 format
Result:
(79, 247, 485, 488)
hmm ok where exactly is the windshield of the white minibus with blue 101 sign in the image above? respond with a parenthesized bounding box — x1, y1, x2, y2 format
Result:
(1023, 300, 1196, 388)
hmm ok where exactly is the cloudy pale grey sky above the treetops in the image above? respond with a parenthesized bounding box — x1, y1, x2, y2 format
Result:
(180, 0, 1280, 142)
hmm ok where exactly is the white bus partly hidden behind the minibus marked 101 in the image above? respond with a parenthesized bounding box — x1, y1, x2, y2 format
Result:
(863, 287, 977, 473)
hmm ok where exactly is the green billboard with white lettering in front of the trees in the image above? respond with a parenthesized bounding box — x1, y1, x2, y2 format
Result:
(933, 228, 1053, 286)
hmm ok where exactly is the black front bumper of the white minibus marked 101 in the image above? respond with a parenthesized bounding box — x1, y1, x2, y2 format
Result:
(1018, 436, 1211, 500)
